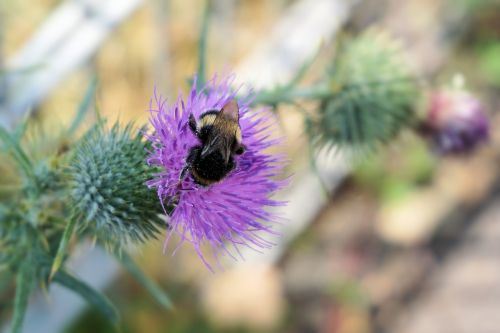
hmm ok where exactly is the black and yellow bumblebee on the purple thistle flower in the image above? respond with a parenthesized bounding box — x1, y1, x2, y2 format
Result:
(180, 100, 245, 186)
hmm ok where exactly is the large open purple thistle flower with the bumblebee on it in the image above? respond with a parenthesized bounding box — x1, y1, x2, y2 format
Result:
(146, 76, 286, 269)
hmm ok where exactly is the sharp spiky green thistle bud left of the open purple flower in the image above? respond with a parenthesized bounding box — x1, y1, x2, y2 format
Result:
(69, 124, 165, 246)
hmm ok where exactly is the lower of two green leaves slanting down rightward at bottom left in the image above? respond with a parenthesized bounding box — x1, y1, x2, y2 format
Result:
(54, 270, 120, 324)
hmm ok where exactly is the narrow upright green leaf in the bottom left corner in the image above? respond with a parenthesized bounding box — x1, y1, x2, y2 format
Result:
(12, 259, 35, 333)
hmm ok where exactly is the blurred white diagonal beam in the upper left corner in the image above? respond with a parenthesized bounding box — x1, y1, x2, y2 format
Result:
(0, 0, 142, 128)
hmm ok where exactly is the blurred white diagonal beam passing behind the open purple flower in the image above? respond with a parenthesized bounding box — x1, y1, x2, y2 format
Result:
(236, 0, 357, 265)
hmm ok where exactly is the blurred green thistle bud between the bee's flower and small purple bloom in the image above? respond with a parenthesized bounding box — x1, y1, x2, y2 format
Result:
(312, 30, 418, 148)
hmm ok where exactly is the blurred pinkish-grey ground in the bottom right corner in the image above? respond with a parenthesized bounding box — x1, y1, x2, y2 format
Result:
(390, 195, 500, 333)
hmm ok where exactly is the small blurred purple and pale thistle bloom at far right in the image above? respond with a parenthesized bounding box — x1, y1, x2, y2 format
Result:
(422, 90, 489, 154)
